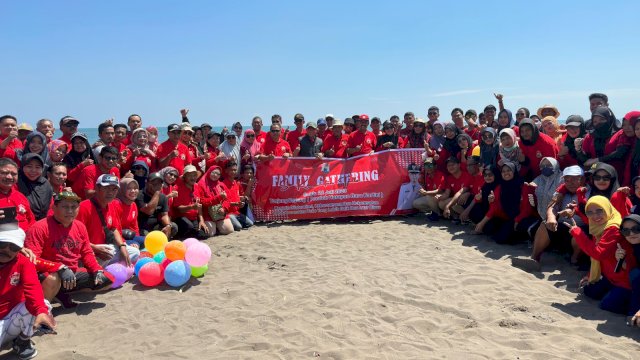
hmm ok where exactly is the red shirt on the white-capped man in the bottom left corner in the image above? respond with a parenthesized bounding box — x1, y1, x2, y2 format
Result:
(0, 253, 49, 319)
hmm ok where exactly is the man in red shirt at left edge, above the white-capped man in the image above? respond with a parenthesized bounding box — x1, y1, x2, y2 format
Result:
(0, 158, 36, 231)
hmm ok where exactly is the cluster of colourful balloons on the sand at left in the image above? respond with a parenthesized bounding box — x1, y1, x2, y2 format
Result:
(105, 231, 211, 288)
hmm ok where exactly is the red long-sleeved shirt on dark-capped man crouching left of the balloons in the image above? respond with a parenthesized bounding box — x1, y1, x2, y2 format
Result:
(24, 216, 102, 274)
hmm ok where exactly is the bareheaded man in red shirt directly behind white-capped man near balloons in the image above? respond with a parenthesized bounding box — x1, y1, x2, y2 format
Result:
(71, 146, 120, 199)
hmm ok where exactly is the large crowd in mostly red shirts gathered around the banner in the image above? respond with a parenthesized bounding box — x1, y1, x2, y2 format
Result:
(0, 93, 640, 358)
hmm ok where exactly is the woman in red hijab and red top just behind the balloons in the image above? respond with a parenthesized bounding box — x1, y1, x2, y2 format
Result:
(115, 178, 142, 246)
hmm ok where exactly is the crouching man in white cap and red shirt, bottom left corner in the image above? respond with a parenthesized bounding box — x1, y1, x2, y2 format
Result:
(0, 229, 56, 359)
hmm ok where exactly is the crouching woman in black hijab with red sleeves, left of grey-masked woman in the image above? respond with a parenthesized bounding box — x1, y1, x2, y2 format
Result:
(475, 161, 539, 244)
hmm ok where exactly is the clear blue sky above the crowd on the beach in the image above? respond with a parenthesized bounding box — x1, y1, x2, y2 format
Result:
(0, 0, 640, 127)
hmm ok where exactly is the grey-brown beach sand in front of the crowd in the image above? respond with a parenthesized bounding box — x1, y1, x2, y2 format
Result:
(0, 216, 640, 360)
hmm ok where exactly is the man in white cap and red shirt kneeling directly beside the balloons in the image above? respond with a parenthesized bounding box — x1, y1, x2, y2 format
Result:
(77, 174, 140, 266)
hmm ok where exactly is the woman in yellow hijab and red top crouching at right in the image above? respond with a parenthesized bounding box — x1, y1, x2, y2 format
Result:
(568, 195, 636, 314)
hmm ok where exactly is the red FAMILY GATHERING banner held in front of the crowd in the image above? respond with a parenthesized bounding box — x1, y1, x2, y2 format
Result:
(252, 149, 423, 221)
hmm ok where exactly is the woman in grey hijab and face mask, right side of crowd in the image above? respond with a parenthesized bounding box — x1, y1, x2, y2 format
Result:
(529, 157, 564, 221)
